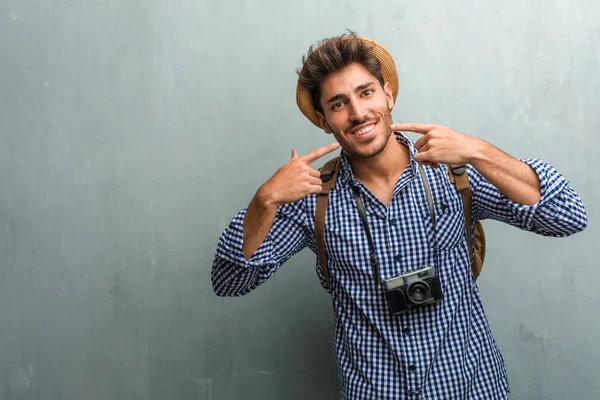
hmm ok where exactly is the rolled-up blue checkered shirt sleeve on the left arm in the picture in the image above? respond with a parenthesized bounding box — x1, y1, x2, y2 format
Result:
(211, 200, 308, 296)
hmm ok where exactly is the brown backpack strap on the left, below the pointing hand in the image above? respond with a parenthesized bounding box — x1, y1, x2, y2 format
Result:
(315, 157, 339, 288)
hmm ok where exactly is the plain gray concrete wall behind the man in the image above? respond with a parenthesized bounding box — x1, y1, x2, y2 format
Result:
(0, 0, 600, 400)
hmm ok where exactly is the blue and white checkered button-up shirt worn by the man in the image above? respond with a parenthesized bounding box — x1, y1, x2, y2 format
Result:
(212, 133, 587, 400)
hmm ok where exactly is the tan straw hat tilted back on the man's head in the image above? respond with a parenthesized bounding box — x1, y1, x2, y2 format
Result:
(296, 36, 399, 128)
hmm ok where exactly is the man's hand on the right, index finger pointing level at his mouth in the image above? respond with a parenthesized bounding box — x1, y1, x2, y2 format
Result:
(391, 123, 489, 168)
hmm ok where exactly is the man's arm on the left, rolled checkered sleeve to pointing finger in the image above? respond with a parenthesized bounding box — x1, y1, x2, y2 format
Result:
(211, 143, 339, 296)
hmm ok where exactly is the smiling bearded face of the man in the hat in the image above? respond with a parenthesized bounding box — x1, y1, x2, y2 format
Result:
(317, 63, 394, 158)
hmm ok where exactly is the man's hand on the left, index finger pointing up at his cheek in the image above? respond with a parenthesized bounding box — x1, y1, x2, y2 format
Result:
(258, 143, 340, 207)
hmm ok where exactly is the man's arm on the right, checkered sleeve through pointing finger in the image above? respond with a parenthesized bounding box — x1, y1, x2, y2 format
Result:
(392, 124, 587, 236)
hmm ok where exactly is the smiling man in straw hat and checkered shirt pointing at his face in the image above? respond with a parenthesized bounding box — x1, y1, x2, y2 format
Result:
(212, 33, 587, 399)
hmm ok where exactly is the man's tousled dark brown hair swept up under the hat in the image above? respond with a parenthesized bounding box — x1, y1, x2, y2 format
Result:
(297, 31, 384, 112)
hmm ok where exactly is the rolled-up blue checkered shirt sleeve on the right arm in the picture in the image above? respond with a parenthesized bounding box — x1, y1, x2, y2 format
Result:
(467, 159, 587, 237)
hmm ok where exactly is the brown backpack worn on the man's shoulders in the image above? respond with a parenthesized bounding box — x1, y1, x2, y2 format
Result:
(315, 157, 486, 287)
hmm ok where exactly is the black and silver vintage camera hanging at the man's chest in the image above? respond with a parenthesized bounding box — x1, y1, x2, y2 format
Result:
(384, 266, 444, 314)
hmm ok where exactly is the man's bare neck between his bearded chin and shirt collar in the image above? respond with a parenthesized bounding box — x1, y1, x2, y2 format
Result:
(347, 134, 410, 184)
